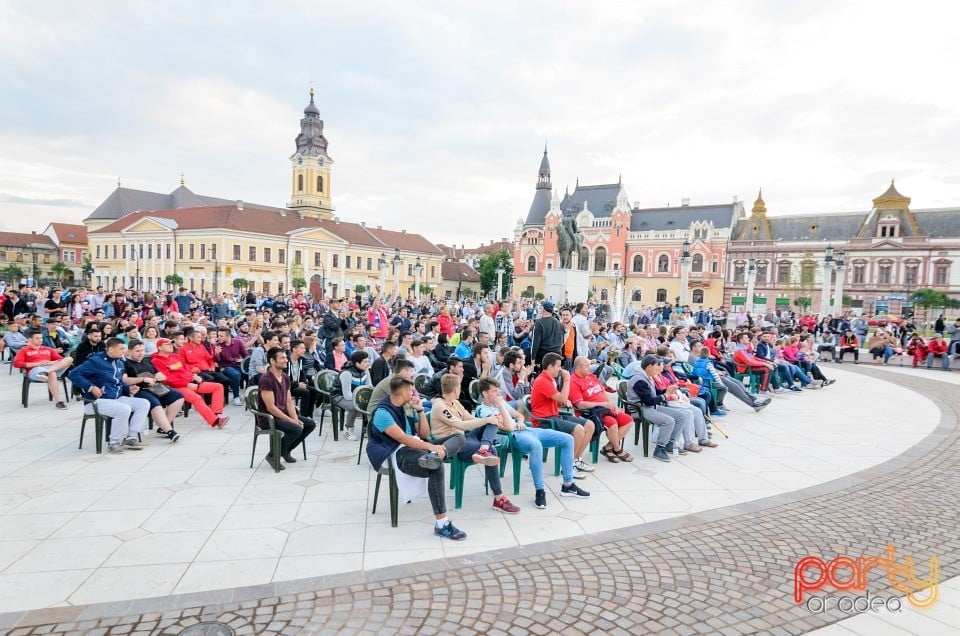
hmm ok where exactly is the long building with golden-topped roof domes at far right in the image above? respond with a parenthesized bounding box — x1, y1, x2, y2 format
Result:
(724, 181, 960, 315)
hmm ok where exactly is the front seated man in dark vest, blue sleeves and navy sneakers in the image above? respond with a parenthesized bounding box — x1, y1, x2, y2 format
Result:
(367, 375, 467, 541)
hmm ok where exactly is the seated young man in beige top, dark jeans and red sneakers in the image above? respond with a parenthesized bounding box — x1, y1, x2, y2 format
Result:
(430, 374, 520, 514)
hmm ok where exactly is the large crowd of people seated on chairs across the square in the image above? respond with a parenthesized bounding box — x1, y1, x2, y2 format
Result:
(0, 286, 960, 540)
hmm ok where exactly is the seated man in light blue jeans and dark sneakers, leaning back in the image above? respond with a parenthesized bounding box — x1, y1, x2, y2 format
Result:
(476, 376, 590, 510)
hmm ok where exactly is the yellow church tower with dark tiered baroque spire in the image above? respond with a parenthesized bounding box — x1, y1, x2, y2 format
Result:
(288, 88, 334, 219)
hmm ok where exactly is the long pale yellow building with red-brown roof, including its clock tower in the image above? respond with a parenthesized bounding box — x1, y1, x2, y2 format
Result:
(84, 90, 444, 296)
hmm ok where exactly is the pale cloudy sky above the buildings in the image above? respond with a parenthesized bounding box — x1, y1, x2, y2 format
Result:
(0, 0, 960, 247)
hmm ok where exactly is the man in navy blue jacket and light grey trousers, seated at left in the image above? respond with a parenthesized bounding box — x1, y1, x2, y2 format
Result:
(67, 338, 150, 453)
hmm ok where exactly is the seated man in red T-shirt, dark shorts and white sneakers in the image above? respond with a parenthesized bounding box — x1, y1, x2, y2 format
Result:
(530, 352, 595, 479)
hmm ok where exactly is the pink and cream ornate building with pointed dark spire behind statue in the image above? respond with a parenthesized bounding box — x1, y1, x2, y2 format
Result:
(514, 149, 745, 309)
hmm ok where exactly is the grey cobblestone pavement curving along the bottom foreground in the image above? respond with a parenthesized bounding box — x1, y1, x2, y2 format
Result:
(0, 367, 960, 636)
